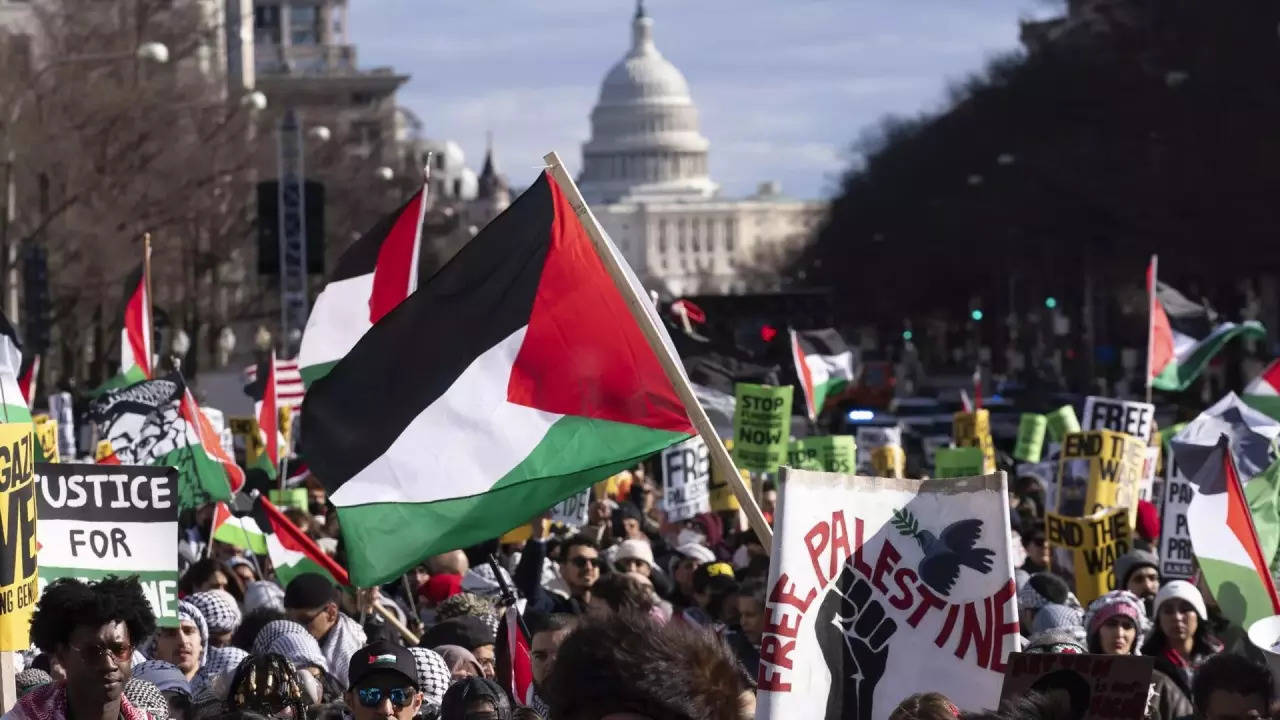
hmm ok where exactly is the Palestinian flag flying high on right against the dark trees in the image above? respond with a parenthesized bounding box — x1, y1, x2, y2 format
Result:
(1147, 261, 1266, 391)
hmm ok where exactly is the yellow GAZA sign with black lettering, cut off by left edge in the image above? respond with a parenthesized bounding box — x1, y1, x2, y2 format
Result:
(0, 423, 36, 651)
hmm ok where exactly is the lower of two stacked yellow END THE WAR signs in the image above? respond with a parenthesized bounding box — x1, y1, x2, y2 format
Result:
(1044, 507, 1133, 605)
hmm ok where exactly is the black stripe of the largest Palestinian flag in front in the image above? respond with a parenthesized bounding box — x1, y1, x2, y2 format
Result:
(301, 174, 554, 492)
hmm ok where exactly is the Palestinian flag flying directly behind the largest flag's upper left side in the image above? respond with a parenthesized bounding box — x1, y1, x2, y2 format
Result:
(298, 187, 426, 387)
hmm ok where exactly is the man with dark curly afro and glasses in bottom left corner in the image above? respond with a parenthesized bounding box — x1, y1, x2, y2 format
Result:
(3, 577, 156, 720)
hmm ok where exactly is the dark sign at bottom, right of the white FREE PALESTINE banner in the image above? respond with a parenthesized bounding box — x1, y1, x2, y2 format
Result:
(1000, 652, 1155, 720)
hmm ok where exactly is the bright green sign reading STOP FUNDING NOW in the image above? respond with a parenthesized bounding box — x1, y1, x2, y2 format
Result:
(733, 383, 792, 473)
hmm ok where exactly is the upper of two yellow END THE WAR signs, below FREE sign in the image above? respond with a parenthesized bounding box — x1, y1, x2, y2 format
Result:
(1057, 430, 1147, 527)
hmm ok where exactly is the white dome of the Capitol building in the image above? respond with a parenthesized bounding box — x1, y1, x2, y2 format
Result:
(579, 5, 717, 202)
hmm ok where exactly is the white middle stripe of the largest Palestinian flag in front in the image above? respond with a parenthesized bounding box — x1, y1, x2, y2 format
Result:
(329, 325, 563, 506)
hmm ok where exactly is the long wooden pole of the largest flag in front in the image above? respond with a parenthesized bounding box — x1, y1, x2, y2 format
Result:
(543, 152, 773, 550)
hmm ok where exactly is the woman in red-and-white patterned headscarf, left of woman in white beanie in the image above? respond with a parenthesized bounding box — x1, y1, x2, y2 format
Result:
(1084, 591, 1196, 720)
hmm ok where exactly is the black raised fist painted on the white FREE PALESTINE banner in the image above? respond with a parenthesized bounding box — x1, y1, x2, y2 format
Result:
(814, 557, 897, 720)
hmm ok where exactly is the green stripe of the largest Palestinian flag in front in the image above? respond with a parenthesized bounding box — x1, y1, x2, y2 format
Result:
(338, 415, 689, 588)
